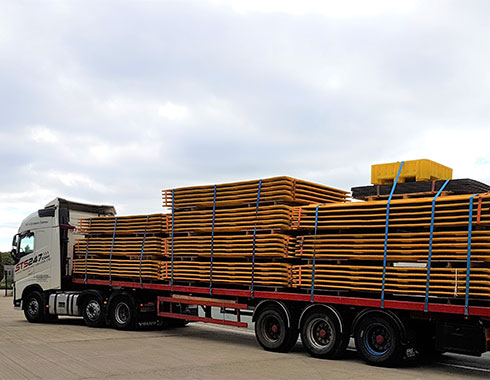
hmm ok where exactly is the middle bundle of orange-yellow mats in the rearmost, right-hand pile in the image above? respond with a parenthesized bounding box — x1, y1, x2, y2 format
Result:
(295, 230, 490, 262)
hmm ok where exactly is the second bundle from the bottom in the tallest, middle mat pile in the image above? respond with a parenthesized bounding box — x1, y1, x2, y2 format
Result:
(164, 234, 294, 257)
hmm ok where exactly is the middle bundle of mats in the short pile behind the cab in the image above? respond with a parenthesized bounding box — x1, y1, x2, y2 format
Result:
(75, 236, 164, 256)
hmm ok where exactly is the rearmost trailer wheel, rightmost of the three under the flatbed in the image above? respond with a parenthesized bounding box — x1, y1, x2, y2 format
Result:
(354, 315, 403, 367)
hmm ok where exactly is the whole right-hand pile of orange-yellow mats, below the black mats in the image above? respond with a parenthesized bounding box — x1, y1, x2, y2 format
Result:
(292, 193, 490, 299)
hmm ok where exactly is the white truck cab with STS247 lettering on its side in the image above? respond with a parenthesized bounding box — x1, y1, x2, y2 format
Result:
(11, 198, 116, 317)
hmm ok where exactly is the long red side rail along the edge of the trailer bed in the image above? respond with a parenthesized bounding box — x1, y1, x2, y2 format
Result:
(72, 278, 490, 318)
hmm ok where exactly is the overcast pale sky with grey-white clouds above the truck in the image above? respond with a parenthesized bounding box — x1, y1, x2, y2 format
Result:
(0, 0, 490, 251)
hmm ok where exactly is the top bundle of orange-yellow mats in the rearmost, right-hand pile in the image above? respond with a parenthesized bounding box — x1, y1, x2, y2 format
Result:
(292, 193, 490, 230)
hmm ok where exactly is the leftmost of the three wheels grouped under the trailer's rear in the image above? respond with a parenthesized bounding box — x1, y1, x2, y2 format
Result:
(255, 306, 299, 352)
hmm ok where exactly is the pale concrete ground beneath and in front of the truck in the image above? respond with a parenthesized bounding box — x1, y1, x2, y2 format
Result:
(0, 294, 490, 380)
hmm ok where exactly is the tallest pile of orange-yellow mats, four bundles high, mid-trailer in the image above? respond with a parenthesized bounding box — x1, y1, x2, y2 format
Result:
(162, 177, 348, 287)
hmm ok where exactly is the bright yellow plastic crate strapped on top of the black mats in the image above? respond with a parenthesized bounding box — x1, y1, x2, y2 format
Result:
(371, 160, 453, 185)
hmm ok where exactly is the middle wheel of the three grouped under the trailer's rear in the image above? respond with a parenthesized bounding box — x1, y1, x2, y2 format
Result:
(301, 311, 350, 359)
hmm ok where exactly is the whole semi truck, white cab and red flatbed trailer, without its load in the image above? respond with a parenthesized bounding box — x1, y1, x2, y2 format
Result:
(11, 193, 490, 366)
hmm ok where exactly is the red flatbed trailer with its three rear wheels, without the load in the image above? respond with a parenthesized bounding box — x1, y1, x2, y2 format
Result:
(72, 278, 490, 365)
